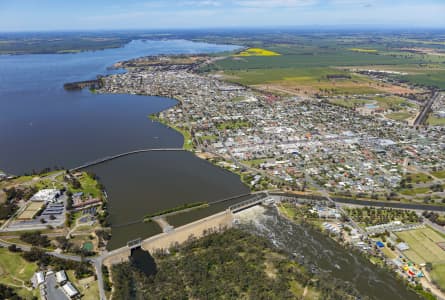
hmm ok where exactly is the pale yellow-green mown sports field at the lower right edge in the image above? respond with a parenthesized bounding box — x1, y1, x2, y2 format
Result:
(397, 227, 445, 265)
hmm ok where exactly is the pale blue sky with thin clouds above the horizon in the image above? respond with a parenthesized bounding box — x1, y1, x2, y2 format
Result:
(0, 0, 445, 31)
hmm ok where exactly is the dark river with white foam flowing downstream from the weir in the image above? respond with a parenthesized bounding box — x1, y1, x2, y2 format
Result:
(236, 207, 420, 300)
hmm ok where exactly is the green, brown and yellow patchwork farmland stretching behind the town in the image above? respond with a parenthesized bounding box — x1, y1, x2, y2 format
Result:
(202, 33, 445, 96)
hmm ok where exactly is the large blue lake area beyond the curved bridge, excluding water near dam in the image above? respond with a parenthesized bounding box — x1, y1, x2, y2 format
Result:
(0, 40, 236, 174)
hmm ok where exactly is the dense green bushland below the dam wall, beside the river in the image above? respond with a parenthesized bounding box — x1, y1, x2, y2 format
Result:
(112, 229, 357, 299)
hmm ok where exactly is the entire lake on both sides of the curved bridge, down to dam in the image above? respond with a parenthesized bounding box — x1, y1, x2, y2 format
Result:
(0, 40, 248, 248)
